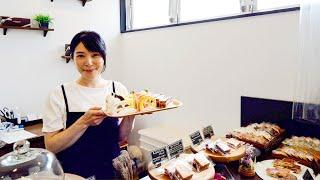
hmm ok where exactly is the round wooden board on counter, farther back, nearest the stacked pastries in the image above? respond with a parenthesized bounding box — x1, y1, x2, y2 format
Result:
(191, 137, 246, 163)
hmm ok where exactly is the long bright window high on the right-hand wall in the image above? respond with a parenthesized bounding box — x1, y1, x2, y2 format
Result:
(121, 0, 301, 32)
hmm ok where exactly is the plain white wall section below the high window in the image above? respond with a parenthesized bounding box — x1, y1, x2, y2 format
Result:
(121, 12, 299, 144)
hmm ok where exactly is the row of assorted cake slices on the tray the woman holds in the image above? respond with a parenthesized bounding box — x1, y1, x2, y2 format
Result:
(104, 90, 182, 117)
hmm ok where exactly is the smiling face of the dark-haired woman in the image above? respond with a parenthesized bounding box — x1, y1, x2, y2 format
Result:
(73, 43, 103, 79)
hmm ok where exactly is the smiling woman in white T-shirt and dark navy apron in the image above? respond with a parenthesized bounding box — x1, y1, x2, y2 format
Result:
(43, 31, 134, 179)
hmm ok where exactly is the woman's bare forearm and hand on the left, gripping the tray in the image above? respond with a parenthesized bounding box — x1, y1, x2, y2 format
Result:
(44, 107, 106, 153)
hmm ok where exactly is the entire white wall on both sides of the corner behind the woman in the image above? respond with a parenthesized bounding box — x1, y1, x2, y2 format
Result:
(0, 0, 299, 146)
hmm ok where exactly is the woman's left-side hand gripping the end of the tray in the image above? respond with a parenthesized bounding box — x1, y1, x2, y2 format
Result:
(79, 107, 107, 127)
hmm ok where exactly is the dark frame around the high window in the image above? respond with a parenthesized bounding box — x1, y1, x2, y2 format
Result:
(120, 0, 300, 33)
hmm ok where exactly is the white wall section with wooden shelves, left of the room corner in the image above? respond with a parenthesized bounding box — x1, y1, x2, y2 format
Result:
(0, 0, 120, 114)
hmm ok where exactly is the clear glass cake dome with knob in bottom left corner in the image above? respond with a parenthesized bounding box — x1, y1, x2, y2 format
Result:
(0, 141, 64, 180)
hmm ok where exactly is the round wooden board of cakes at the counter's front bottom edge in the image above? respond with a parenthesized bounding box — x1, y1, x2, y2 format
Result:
(148, 163, 215, 180)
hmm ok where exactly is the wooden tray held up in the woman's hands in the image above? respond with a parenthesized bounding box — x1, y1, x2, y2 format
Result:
(106, 99, 182, 118)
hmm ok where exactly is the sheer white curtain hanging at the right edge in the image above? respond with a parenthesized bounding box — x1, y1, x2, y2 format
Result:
(293, 0, 320, 124)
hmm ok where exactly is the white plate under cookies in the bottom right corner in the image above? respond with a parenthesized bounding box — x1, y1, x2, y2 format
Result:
(255, 159, 319, 180)
